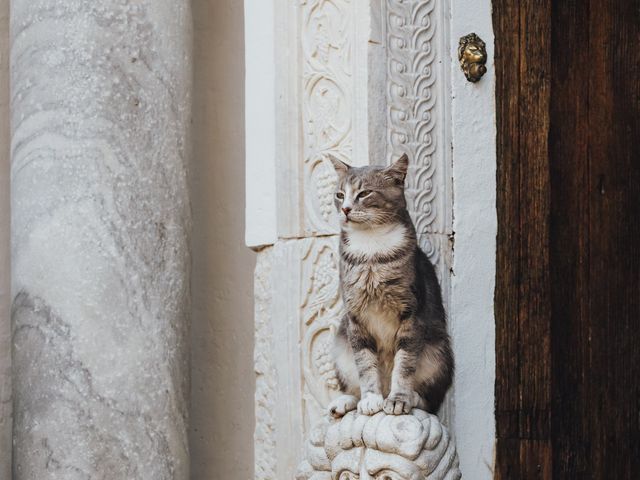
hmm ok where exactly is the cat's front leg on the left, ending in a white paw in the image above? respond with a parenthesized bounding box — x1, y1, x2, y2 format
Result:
(349, 321, 384, 415)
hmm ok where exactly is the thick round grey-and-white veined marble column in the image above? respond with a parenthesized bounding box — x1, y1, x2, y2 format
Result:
(11, 0, 191, 480)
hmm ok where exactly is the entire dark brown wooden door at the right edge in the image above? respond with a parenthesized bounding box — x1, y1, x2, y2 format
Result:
(493, 0, 640, 480)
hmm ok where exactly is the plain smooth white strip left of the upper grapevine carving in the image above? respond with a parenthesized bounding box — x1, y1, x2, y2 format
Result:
(244, 0, 277, 247)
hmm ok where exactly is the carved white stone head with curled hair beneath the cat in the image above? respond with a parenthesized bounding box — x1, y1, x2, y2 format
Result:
(296, 409, 462, 480)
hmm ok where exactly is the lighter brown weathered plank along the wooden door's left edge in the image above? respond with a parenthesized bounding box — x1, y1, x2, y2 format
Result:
(494, 0, 551, 480)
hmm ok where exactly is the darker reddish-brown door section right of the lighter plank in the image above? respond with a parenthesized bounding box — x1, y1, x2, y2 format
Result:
(550, 0, 640, 479)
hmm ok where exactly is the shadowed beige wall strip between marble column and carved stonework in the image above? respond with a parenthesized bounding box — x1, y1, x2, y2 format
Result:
(189, 0, 255, 480)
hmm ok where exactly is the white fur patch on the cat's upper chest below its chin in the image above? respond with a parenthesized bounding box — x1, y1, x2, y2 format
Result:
(344, 224, 406, 257)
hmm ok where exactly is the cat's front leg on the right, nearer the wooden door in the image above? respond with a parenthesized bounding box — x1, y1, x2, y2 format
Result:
(383, 326, 421, 415)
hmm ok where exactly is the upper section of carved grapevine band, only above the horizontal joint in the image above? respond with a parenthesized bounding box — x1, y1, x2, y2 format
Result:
(300, 0, 353, 234)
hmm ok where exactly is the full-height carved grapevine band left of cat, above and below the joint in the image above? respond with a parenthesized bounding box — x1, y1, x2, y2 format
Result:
(299, 0, 355, 428)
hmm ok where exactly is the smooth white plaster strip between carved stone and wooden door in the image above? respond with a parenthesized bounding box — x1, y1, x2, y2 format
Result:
(450, 0, 497, 480)
